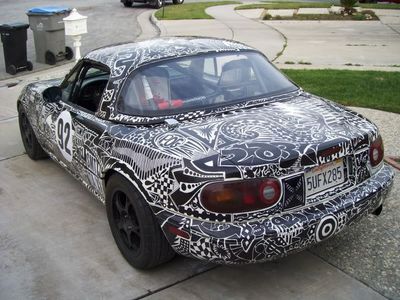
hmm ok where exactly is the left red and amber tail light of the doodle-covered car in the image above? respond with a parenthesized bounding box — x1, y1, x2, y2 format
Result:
(200, 178, 281, 213)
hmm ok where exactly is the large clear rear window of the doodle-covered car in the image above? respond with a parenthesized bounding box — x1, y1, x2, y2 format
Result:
(118, 51, 297, 116)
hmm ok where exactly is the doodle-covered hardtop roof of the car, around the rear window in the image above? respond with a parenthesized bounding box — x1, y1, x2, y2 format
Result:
(47, 37, 298, 125)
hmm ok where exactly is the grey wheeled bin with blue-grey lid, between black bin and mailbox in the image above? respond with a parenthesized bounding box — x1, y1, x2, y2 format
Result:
(26, 6, 74, 65)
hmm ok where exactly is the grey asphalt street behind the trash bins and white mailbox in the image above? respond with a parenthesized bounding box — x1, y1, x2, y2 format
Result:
(0, 0, 151, 80)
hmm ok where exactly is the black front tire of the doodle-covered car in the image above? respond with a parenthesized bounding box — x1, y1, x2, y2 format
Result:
(18, 106, 48, 160)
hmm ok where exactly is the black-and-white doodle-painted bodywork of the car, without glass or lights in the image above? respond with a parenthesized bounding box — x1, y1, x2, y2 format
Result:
(19, 38, 393, 263)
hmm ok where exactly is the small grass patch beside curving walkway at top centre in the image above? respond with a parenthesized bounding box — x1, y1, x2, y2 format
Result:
(155, 1, 241, 20)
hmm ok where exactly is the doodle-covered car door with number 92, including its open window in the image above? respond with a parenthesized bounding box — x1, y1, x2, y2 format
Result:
(51, 61, 110, 197)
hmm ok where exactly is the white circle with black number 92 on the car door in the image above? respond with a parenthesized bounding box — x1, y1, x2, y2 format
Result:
(55, 111, 74, 161)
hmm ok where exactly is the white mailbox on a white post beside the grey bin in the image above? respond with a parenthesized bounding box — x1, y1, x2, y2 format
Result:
(63, 8, 87, 61)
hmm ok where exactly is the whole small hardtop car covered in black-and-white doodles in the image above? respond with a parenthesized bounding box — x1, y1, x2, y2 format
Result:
(18, 37, 394, 269)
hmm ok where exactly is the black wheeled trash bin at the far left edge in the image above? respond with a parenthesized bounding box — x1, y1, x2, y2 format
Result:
(0, 23, 32, 75)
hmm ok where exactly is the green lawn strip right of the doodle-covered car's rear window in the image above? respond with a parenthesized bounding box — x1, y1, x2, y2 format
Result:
(282, 69, 400, 113)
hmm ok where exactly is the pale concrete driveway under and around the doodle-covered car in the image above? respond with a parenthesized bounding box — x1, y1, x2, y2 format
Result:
(0, 66, 400, 299)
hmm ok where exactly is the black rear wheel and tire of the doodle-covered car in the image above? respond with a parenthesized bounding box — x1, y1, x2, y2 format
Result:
(106, 174, 175, 269)
